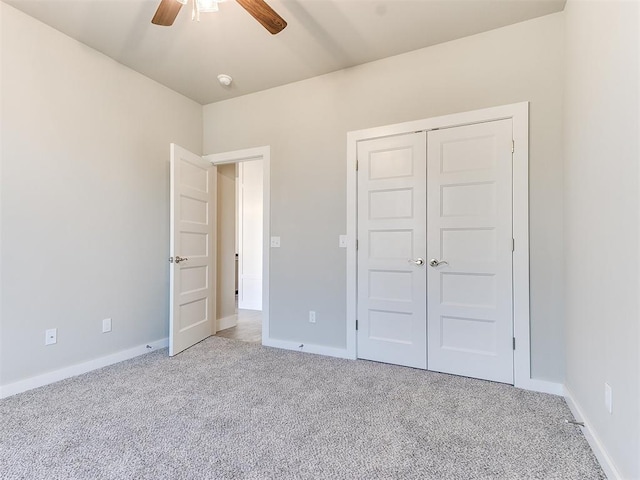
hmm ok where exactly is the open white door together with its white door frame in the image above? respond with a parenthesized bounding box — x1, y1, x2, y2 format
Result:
(169, 144, 270, 356)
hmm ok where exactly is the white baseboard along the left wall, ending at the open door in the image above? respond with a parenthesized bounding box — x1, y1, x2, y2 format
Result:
(0, 338, 169, 398)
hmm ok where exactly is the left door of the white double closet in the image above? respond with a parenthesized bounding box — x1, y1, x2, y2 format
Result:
(358, 132, 426, 368)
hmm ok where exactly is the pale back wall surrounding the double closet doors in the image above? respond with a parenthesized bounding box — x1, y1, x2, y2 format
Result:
(203, 13, 564, 381)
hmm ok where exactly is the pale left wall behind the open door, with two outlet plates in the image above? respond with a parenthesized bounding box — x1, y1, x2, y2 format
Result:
(0, 3, 202, 385)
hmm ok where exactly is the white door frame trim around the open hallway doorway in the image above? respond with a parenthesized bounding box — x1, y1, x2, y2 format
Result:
(202, 145, 271, 345)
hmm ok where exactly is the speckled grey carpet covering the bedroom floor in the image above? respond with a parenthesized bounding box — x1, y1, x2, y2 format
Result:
(0, 337, 604, 480)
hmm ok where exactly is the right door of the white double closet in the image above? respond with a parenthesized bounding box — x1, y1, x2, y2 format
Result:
(427, 120, 513, 384)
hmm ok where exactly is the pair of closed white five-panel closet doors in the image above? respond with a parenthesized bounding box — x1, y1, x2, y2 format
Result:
(357, 119, 513, 384)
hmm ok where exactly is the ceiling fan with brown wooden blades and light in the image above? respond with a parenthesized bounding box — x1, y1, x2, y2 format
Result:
(151, 0, 287, 35)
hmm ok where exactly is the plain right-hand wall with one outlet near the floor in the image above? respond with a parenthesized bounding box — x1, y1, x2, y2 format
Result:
(564, 1, 640, 478)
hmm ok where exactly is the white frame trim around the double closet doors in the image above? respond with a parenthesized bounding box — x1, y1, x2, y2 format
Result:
(346, 102, 544, 393)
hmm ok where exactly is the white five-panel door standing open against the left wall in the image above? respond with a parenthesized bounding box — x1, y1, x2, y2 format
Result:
(169, 143, 216, 356)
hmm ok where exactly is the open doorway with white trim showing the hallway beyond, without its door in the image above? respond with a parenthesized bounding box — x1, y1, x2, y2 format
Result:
(203, 146, 270, 344)
